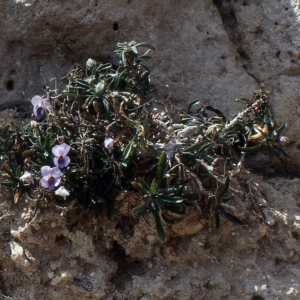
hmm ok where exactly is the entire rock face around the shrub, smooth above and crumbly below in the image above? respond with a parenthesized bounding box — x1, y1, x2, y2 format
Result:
(0, 0, 300, 300)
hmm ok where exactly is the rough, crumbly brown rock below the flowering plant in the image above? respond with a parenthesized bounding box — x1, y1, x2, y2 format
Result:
(0, 175, 300, 300)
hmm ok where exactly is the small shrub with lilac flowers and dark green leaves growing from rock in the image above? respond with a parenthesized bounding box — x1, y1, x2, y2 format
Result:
(0, 41, 288, 241)
